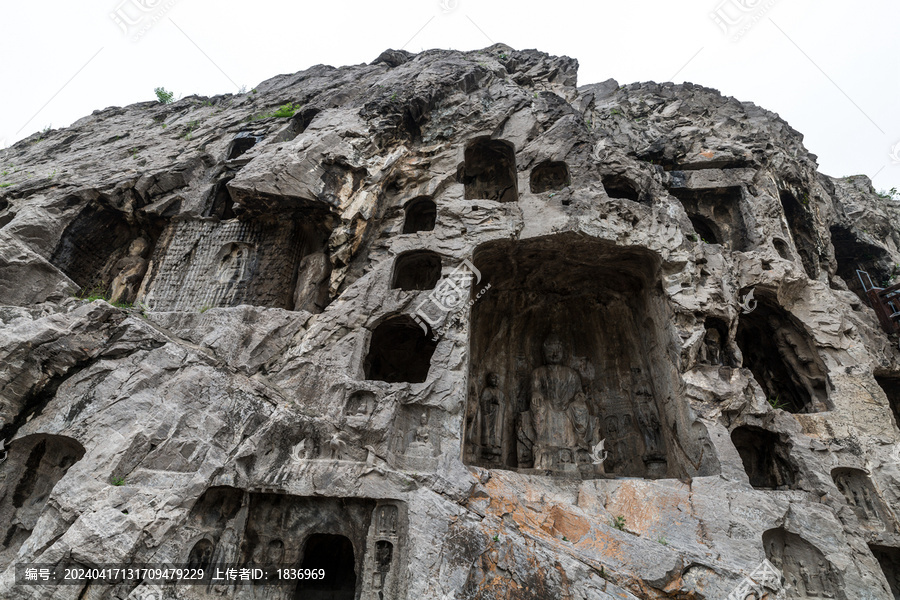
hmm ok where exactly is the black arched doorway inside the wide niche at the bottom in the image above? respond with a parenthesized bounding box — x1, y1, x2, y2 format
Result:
(294, 533, 356, 600)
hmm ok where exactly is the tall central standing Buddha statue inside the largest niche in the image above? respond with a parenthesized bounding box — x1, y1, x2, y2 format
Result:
(530, 335, 593, 469)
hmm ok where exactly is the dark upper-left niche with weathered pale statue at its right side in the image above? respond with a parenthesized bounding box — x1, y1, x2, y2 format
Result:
(50, 203, 165, 302)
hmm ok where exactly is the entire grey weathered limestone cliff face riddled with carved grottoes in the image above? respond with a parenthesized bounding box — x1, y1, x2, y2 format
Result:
(0, 45, 900, 600)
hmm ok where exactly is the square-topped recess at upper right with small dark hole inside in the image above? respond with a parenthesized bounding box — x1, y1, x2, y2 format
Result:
(669, 186, 747, 251)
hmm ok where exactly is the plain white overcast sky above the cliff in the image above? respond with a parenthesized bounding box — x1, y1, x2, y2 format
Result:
(0, 0, 900, 189)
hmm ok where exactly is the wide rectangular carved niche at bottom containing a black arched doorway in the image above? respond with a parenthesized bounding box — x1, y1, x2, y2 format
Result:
(183, 487, 408, 600)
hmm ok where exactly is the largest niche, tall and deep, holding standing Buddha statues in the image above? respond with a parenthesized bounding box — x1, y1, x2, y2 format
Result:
(463, 234, 719, 478)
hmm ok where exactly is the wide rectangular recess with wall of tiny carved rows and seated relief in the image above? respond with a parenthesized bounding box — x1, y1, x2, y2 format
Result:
(143, 218, 330, 312)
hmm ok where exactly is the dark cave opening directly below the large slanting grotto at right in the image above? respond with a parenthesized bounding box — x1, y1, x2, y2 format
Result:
(731, 425, 797, 490)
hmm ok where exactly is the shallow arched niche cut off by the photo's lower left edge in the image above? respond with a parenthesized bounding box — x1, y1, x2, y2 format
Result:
(0, 434, 84, 569)
